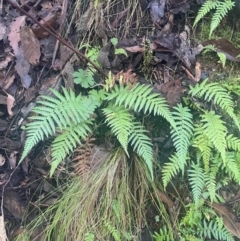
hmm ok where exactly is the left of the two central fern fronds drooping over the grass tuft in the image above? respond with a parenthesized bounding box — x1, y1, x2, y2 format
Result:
(103, 105, 133, 155)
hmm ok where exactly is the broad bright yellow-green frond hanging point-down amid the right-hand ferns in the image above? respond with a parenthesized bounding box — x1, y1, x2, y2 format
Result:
(201, 111, 227, 162)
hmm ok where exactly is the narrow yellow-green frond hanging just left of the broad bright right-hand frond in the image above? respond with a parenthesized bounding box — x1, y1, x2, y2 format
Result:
(193, 126, 212, 173)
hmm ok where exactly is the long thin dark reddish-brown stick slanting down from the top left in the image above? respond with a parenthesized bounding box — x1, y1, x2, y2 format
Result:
(6, 0, 107, 77)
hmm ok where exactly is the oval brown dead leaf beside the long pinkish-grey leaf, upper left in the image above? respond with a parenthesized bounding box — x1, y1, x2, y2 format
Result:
(20, 26, 41, 65)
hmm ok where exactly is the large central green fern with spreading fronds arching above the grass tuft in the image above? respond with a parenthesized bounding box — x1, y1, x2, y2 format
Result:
(20, 78, 175, 178)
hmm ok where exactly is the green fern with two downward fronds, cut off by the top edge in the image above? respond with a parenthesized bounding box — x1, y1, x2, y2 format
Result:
(193, 0, 235, 37)
